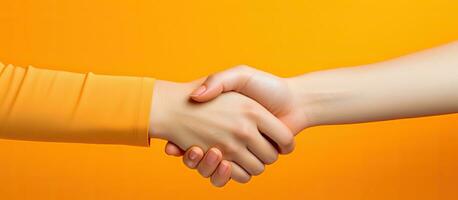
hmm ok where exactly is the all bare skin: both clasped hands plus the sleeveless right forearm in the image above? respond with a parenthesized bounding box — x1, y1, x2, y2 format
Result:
(149, 42, 458, 187)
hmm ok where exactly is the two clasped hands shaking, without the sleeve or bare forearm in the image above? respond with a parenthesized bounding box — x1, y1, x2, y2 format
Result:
(150, 66, 311, 186)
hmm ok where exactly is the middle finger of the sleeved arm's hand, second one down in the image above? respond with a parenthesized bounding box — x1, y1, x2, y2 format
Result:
(247, 130, 278, 164)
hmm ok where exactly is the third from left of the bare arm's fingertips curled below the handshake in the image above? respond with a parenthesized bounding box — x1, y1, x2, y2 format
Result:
(197, 148, 223, 177)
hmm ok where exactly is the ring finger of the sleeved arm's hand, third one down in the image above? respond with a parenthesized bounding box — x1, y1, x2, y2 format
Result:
(234, 149, 264, 176)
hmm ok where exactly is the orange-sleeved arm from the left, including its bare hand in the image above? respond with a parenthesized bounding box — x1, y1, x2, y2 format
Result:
(0, 62, 294, 182)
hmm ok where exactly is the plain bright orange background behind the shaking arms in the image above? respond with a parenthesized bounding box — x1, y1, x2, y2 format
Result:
(0, 0, 458, 199)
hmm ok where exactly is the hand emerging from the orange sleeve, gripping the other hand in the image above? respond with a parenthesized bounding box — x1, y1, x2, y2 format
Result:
(150, 80, 294, 183)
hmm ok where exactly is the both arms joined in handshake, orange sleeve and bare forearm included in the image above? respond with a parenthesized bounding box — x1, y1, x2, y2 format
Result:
(0, 42, 458, 187)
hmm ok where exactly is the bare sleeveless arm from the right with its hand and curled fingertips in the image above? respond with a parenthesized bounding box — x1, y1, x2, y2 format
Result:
(166, 42, 458, 186)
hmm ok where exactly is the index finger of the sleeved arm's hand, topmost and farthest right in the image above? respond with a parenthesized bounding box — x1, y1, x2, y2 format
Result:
(257, 108, 294, 154)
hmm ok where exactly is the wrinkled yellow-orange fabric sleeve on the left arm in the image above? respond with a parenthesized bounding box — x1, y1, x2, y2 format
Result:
(0, 63, 154, 146)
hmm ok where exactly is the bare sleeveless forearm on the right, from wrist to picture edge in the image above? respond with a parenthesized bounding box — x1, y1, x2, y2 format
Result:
(288, 42, 458, 126)
